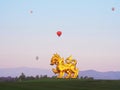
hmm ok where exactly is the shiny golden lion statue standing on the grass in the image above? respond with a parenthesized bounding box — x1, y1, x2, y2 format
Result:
(50, 53, 79, 78)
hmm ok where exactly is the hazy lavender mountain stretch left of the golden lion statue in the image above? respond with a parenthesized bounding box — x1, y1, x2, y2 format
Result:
(0, 67, 54, 77)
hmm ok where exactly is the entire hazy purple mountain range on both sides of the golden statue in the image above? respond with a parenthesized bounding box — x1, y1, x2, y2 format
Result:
(0, 67, 120, 80)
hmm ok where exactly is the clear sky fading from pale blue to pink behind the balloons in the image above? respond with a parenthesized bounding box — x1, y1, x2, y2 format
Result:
(0, 0, 120, 71)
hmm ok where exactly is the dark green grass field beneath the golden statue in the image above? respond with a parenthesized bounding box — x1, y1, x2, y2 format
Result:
(0, 79, 120, 90)
